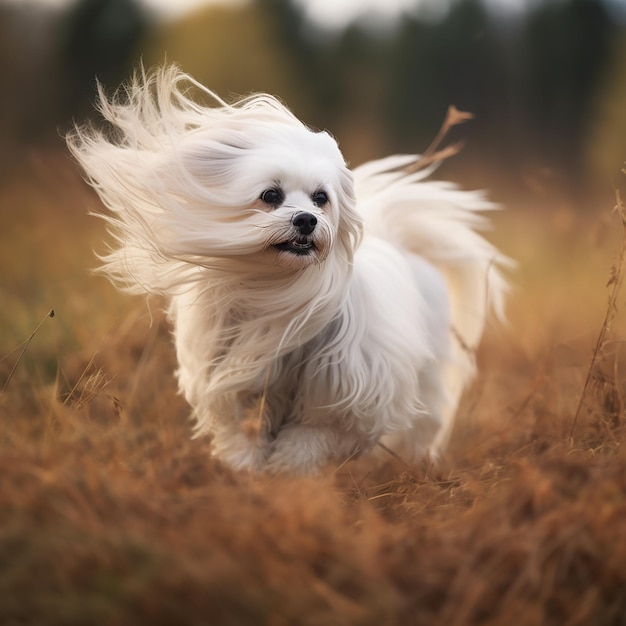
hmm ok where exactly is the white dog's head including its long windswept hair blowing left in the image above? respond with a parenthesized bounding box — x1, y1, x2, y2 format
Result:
(68, 66, 362, 292)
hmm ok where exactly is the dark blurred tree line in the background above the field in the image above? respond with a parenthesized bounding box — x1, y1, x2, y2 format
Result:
(0, 0, 626, 205)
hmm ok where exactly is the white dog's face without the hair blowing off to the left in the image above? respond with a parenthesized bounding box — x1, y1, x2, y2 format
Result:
(162, 115, 362, 270)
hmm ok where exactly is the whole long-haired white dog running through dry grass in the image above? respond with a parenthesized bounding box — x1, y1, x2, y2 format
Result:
(68, 67, 507, 473)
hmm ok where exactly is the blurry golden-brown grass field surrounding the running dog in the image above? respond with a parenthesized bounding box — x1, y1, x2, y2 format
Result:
(0, 154, 626, 626)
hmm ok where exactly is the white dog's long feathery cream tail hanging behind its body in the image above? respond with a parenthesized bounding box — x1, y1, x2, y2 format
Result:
(354, 155, 513, 454)
